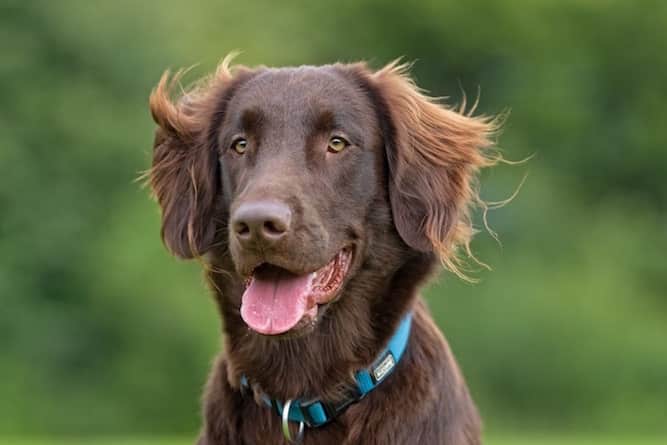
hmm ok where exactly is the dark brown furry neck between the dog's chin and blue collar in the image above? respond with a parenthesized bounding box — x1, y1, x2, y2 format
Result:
(209, 250, 434, 400)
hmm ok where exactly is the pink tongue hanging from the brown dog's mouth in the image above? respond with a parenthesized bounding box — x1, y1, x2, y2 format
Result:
(241, 267, 312, 335)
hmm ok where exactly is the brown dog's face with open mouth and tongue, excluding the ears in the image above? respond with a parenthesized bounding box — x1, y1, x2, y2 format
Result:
(222, 67, 382, 334)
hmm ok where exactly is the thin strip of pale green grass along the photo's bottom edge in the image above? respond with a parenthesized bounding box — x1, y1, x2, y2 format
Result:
(0, 434, 667, 445)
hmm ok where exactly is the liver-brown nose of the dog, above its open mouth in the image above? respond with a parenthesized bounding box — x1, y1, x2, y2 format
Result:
(231, 201, 292, 247)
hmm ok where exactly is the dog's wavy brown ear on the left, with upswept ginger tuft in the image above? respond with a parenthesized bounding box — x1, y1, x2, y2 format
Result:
(149, 59, 248, 258)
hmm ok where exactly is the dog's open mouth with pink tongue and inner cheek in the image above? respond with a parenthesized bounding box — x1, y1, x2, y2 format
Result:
(241, 248, 352, 335)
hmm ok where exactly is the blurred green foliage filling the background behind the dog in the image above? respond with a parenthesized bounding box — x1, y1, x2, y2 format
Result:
(0, 0, 667, 435)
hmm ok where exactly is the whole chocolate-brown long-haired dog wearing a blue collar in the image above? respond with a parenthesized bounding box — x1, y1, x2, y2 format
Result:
(149, 58, 496, 445)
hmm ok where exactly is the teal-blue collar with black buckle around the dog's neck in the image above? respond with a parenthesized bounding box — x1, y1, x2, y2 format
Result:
(241, 312, 412, 428)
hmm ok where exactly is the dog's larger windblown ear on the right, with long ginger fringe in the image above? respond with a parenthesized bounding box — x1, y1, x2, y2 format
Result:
(362, 62, 497, 278)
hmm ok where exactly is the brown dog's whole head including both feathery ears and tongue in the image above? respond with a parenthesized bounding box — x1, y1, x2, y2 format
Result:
(151, 58, 493, 335)
